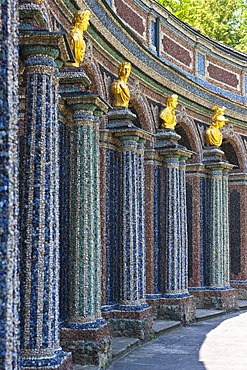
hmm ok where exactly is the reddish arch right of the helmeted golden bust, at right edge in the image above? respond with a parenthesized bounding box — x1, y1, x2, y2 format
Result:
(222, 132, 247, 173)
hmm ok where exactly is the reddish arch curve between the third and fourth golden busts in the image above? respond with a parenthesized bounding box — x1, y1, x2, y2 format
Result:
(175, 111, 203, 163)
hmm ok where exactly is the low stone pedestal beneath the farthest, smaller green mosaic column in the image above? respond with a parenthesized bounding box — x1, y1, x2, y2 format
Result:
(190, 287, 237, 312)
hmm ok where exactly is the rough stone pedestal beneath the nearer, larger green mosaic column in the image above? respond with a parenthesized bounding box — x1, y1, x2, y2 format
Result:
(60, 319, 112, 369)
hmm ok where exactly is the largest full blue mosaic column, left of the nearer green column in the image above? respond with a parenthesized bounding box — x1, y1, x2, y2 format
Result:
(20, 46, 72, 369)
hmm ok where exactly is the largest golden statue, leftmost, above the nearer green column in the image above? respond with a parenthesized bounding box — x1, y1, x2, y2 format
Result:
(67, 10, 90, 67)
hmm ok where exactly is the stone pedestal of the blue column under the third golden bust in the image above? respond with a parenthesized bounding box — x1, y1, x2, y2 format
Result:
(147, 294, 195, 325)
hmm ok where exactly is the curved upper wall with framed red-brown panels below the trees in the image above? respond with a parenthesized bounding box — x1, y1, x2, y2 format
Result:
(110, 0, 247, 102)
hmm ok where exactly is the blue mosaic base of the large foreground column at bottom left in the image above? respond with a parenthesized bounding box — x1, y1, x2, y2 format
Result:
(21, 351, 73, 370)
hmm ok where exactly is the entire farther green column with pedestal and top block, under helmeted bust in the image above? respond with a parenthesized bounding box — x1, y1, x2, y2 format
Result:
(193, 147, 236, 310)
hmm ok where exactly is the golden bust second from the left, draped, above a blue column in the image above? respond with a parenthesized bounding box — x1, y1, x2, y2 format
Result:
(111, 62, 131, 108)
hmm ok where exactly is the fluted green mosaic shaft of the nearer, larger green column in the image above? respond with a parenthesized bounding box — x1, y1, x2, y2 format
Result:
(70, 111, 101, 323)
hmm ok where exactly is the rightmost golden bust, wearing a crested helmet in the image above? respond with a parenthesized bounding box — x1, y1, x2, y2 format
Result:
(206, 105, 228, 146)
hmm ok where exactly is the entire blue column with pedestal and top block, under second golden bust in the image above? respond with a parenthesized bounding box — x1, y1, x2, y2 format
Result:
(106, 108, 152, 340)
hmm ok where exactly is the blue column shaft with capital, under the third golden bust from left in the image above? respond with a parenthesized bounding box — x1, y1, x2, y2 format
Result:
(162, 149, 190, 298)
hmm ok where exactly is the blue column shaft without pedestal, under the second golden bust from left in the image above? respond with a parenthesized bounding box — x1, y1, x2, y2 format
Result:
(119, 133, 147, 310)
